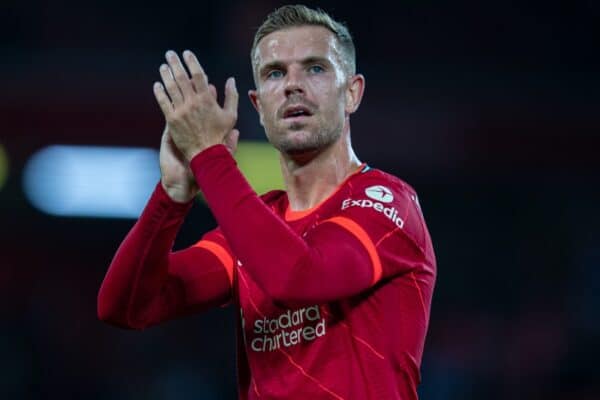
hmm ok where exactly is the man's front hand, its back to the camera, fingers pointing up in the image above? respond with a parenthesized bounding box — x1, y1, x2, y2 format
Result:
(154, 51, 239, 161)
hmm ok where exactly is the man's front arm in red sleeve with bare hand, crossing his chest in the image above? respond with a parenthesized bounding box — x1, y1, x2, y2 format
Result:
(149, 51, 424, 302)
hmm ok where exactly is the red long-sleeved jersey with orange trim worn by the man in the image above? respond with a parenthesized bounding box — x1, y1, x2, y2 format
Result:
(98, 145, 436, 400)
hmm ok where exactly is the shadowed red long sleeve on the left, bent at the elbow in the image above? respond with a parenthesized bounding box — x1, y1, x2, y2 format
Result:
(98, 183, 233, 329)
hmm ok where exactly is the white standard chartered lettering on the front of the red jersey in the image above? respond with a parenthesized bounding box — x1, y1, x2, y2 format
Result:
(250, 305, 326, 352)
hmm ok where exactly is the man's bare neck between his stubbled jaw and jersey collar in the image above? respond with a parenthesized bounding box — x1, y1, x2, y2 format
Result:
(280, 124, 360, 211)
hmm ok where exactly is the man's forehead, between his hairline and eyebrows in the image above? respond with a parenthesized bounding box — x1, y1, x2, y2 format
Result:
(256, 26, 340, 65)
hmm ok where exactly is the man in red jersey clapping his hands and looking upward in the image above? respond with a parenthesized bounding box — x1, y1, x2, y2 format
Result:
(98, 6, 436, 400)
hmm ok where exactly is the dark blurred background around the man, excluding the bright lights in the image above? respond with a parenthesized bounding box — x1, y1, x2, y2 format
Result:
(0, 0, 600, 400)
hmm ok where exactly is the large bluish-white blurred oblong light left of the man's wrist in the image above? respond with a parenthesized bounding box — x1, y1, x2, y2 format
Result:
(23, 145, 160, 218)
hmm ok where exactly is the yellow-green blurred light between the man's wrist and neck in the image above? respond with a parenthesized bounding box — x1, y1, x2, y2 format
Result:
(235, 141, 284, 194)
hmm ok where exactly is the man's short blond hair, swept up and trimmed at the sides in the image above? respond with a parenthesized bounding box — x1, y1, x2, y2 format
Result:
(250, 4, 356, 77)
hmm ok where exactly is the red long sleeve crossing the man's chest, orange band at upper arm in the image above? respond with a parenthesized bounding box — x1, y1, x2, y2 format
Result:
(190, 145, 428, 304)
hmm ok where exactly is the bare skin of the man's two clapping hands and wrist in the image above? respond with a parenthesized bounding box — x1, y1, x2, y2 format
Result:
(154, 50, 239, 203)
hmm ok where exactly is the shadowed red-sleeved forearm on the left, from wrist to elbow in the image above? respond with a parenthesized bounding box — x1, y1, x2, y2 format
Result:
(98, 185, 192, 328)
